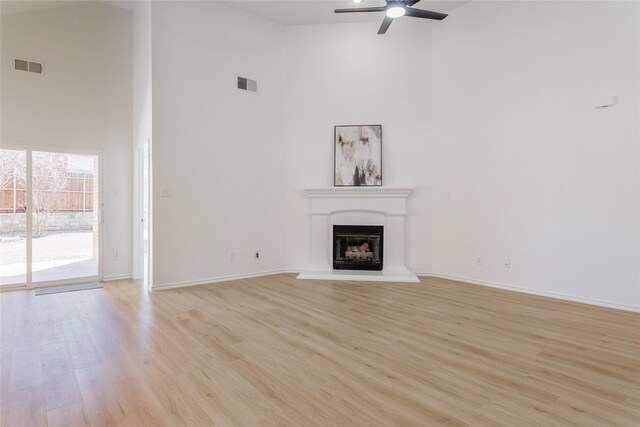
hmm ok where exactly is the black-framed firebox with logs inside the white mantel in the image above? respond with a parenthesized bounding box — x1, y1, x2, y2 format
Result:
(333, 225, 384, 271)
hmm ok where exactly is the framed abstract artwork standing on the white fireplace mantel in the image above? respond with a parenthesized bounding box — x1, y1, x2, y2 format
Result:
(333, 125, 382, 187)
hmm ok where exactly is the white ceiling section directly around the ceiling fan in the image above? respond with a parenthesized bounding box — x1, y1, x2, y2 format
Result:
(225, 0, 470, 25)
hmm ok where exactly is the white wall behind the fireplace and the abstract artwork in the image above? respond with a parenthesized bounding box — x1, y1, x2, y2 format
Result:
(285, 20, 433, 272)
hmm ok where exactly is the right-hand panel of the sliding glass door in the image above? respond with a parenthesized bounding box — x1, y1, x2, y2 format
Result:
(31, 151, 98, 282)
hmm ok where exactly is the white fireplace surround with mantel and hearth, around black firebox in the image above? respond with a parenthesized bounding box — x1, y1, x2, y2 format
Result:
(298, 187, 419, 282)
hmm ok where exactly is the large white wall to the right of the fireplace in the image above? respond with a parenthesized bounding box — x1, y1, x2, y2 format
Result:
(433, 2, 640, 308)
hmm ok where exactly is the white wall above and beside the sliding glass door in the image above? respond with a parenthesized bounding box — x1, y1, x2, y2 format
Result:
(0, 4, 132, 278)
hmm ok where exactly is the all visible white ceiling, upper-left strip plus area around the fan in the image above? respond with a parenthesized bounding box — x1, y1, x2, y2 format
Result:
(0, 0, 470, 25)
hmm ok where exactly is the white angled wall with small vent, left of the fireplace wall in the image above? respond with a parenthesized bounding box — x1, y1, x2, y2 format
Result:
(152, 2, 285, 288)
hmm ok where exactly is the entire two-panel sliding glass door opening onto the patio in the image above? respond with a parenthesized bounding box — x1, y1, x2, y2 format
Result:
(0, 150, 100, 286)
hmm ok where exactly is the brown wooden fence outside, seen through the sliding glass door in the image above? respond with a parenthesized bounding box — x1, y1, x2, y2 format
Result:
(0, 173, 93, 213)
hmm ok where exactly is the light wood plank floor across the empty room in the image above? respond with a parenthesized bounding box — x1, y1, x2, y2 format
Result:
(0, 275, 640, 427)
